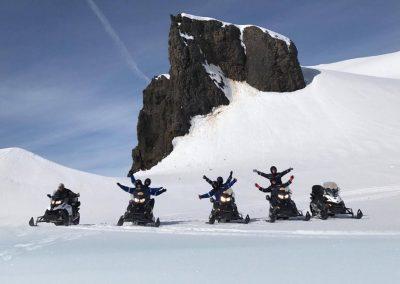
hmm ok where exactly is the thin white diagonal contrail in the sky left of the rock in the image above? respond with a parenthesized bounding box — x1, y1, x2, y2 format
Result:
(86, 0, 150, 82)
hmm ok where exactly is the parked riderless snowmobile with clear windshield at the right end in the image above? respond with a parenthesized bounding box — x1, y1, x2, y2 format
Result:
(310, 182, 363, 220)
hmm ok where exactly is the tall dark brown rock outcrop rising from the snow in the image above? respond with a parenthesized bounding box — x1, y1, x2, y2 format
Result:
(131, 14, 305, 172)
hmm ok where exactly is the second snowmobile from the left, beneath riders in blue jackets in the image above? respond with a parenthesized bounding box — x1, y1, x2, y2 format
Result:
(117, 191, 160, 227)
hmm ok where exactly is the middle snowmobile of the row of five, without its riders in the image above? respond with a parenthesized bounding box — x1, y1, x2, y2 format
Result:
(208, 189, 250, 224)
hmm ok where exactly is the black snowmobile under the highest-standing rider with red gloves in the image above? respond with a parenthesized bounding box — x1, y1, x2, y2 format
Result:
(266, 187, 311, 223)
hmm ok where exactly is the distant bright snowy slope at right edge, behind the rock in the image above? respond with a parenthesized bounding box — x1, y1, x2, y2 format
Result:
(316, 51, 400, 79)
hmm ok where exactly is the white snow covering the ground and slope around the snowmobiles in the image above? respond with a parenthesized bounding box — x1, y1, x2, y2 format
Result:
(0, 52, 400, 283)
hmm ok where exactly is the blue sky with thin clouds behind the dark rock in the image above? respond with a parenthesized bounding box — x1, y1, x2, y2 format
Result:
(0, 0, 400, 176)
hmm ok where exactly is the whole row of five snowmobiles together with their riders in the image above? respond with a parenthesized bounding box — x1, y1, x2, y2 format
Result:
(29, 166, 363, 227)
